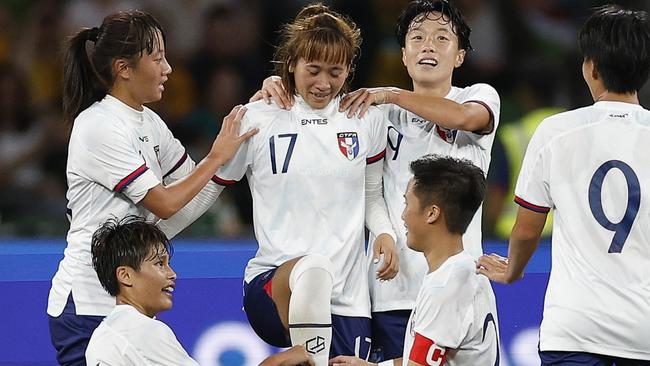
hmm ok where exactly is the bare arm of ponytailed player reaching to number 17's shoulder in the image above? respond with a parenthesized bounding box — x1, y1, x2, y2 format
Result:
(142, 106, 257, 219)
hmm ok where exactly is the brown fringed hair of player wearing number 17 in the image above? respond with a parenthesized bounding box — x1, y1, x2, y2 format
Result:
(274, 4, 361, 95)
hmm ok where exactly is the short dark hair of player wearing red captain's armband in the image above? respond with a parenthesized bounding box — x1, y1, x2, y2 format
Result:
(410, 154, 485, 234)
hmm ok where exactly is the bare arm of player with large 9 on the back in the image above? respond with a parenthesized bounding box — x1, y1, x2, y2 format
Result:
(476, 207, 546, 284)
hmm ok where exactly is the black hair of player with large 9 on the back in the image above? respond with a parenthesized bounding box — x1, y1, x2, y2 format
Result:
(579, 5, 650, 93)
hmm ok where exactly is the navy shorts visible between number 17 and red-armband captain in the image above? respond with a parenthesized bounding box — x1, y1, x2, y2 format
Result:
(369, 310, 411, 363)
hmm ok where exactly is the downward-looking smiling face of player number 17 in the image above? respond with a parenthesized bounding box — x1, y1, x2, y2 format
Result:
(290, 58, 350, 109)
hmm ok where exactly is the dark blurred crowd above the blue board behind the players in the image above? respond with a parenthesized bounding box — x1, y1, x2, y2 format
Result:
(0, 0, 650, 239)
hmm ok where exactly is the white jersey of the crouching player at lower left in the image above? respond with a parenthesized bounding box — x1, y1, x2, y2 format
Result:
(86, 305, 198, 366)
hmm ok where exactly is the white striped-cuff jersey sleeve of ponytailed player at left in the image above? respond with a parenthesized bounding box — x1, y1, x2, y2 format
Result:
(74, 115, 160, 203)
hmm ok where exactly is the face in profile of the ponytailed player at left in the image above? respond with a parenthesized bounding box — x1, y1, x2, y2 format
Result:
(127, 31, 172, 106)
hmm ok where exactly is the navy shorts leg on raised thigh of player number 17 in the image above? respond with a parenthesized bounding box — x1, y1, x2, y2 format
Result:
(244, 269, 291, 347)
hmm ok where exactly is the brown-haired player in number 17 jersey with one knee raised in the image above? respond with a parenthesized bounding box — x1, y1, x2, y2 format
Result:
(161, 5, 397, 365)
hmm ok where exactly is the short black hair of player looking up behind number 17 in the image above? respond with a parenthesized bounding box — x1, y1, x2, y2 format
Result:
(395, 0, 472, 51)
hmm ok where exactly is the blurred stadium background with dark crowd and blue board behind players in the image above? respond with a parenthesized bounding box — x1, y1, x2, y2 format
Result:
(0, 0, 650, 366)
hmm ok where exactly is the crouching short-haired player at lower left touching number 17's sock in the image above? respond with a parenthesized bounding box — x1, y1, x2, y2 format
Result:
(86, 215, 314, 366)
